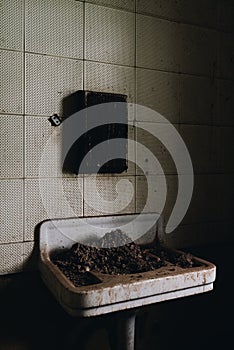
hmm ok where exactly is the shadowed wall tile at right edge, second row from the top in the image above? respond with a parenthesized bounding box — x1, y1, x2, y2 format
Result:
(218, 32, 234, 79)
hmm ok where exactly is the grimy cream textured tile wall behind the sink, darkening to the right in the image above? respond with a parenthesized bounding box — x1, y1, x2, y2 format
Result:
(0, 0, 234, 273)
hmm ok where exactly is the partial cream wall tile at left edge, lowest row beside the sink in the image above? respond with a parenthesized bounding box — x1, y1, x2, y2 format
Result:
(0, 243, 24, 275)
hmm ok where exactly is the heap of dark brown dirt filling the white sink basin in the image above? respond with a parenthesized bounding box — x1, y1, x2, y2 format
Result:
(51, 230, 197, 286)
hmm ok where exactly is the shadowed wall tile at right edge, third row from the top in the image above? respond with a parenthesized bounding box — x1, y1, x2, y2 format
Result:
(216, 80, 234, 126)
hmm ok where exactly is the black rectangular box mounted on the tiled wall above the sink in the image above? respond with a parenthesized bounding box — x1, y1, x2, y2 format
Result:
(63, 90, 128, 174)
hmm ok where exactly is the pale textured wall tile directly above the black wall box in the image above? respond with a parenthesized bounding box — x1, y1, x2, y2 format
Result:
(84, 62, 135, 102)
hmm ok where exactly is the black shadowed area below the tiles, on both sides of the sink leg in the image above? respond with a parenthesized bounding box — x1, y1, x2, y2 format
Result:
(0, 244, 234, 350)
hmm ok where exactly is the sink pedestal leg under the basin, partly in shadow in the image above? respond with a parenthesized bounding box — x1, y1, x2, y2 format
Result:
(108, 311, 136, 350)
